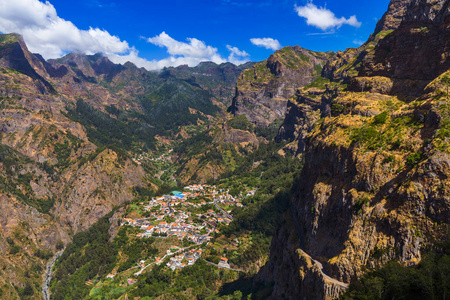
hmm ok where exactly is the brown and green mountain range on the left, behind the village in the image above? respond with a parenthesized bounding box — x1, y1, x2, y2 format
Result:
(0, 34, 253, 299)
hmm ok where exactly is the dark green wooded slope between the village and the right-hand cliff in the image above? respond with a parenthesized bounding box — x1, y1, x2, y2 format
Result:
(214, 142, 302, 267)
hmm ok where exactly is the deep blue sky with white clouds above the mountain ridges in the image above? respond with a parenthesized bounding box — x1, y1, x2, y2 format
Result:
(0, 0, 389, 69)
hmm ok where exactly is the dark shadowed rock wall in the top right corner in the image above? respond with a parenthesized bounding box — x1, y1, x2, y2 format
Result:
(351, 0, 450, 96)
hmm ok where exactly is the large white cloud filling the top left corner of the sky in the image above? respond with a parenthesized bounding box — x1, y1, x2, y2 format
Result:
(0, 0, 131, 58)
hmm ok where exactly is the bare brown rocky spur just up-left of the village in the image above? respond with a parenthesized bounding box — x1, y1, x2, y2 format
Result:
(53, 149, 145, 233)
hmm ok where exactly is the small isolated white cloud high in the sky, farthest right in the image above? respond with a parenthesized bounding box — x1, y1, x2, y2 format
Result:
(295, 2, 361, 31)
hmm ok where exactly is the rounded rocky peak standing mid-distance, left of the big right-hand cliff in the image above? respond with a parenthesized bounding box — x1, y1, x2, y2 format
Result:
(230, 46, 331, 126)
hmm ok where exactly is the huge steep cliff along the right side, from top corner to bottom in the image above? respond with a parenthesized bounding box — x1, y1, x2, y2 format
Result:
(258, 1, 450, 299)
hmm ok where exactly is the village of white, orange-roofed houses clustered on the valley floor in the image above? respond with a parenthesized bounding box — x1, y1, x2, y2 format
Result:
(121, 184, 255, 275)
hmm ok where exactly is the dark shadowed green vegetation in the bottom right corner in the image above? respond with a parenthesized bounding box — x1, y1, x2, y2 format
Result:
(342, 240, 450, 299)
